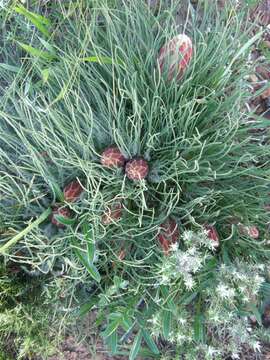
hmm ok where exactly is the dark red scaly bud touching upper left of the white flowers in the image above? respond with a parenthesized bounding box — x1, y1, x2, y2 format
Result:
(158, 218, 180, 255)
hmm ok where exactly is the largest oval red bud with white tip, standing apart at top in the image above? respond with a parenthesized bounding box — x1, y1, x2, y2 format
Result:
(158, 34, 193, 81)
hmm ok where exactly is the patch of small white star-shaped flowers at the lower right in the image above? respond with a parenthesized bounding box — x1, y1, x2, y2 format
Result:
(152, 231, 267, 360)
